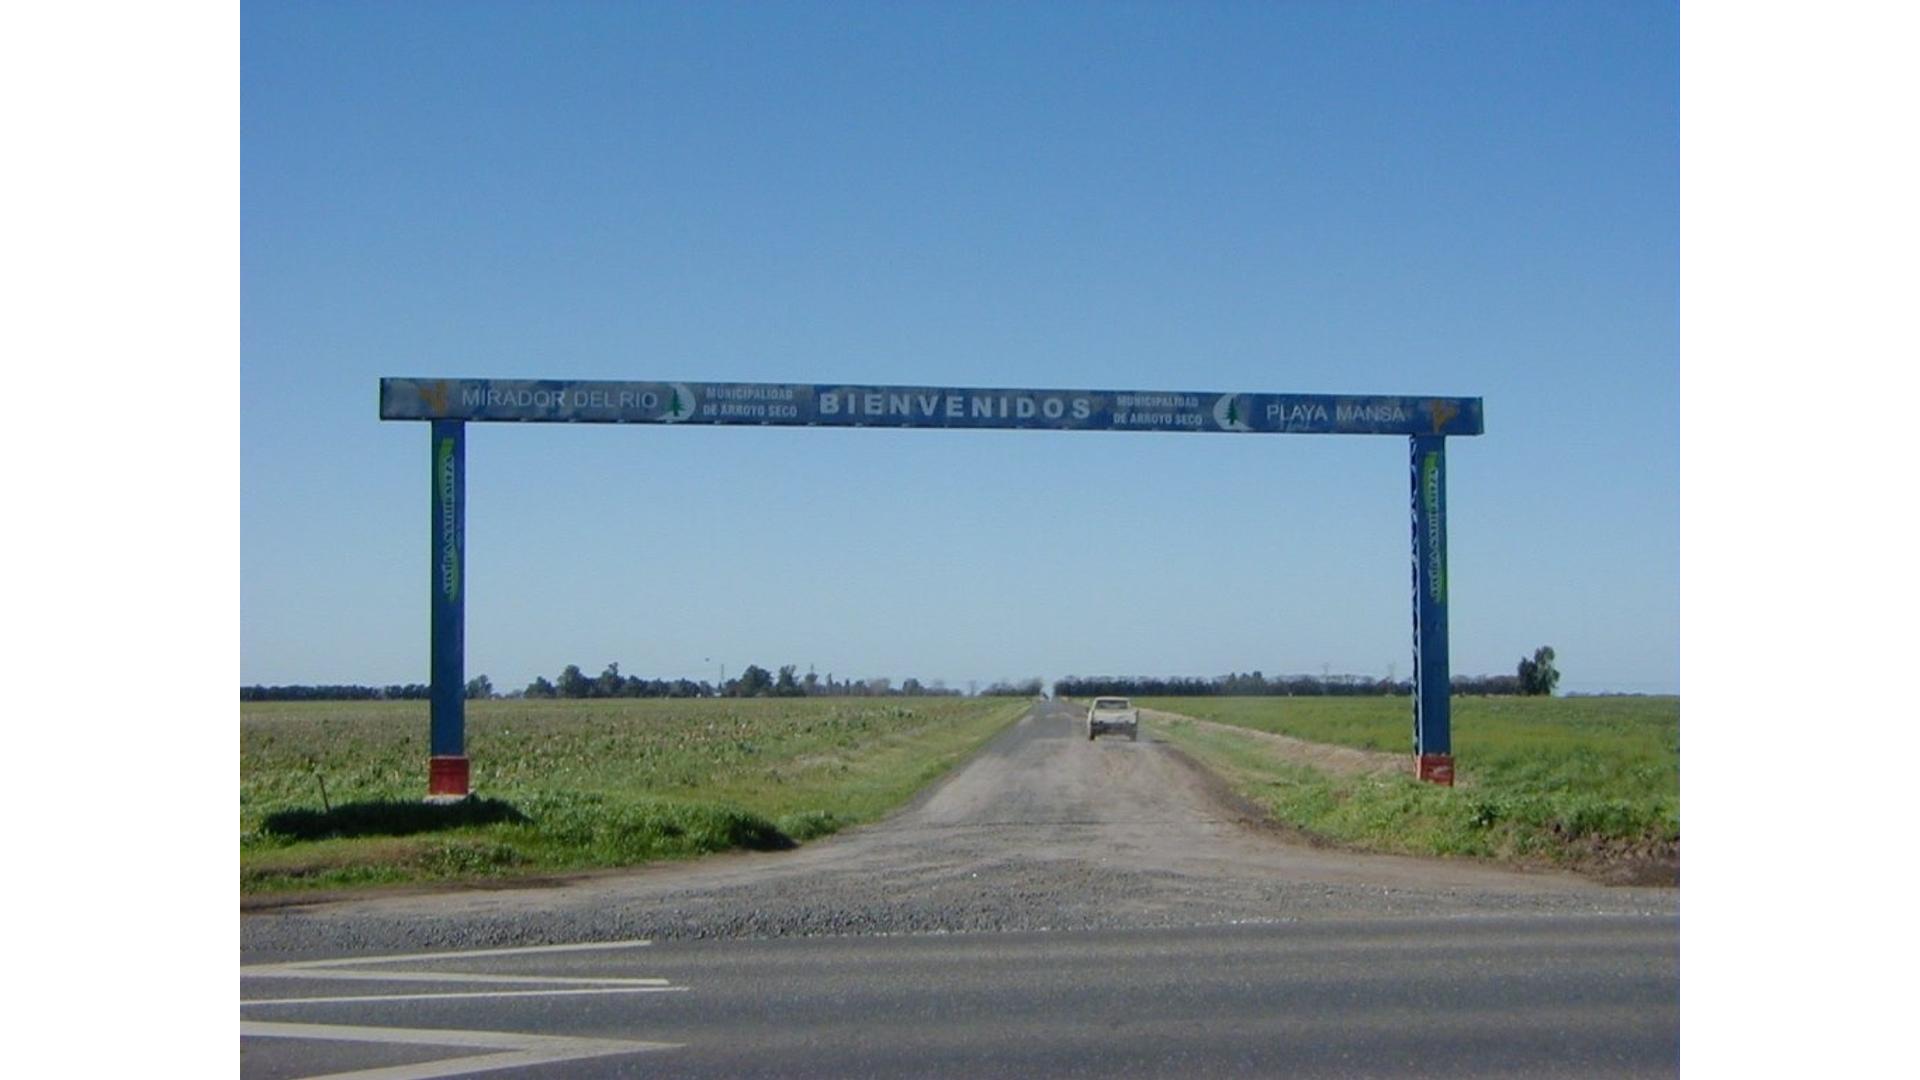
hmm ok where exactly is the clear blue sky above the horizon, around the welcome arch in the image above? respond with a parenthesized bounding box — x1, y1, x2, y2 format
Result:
(240, 2, 1680, 692)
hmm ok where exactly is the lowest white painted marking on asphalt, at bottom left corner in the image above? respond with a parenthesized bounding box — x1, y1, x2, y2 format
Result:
(240, 1020, 680, 1080)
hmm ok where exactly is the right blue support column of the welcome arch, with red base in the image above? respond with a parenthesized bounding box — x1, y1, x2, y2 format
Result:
(1409, 434, 1453, 786)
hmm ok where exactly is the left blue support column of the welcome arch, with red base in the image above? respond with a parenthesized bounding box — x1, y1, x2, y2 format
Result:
(426, 421, 468, 798)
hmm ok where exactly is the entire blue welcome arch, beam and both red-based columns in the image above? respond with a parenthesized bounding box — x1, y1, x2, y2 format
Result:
(380, 379, 1484, 798)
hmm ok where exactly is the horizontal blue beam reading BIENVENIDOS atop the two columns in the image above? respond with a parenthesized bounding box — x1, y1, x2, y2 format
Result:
(380, 379, 1484, 434)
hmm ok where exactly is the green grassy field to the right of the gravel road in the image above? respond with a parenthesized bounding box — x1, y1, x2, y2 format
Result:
(1140, 698, 1680, 884)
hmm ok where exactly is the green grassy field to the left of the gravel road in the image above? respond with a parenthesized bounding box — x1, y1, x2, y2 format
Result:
(240, 698, 1027, 894)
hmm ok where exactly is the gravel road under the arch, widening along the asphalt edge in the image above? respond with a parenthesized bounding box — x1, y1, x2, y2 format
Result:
(242, 701, 1678, 963)
